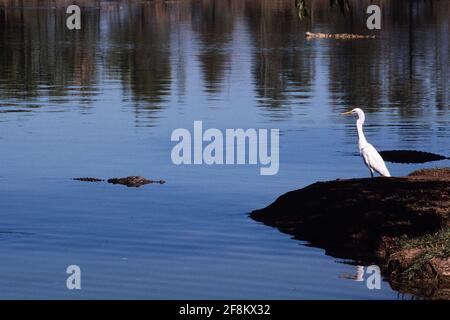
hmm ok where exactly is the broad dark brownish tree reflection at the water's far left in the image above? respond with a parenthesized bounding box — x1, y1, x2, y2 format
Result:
(0, 1, 100, 109)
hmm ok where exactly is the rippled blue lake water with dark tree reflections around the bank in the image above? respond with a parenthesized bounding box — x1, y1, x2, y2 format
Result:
(0, 0, 450, 299)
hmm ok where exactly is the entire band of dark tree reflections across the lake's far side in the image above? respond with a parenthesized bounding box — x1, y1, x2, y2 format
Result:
(0, 0, 450, 123)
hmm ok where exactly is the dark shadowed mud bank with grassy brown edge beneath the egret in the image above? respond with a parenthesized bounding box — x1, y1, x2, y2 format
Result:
(251, 168, 450, 299)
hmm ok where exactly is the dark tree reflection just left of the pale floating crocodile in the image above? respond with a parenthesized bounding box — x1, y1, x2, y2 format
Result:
(245, 1, 315, 112)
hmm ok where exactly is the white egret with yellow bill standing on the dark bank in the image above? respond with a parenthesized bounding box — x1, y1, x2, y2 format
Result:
(342, 108, 391, 178)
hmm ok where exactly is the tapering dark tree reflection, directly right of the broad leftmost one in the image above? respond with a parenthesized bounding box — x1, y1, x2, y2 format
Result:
(102, 2, 171, 122)
